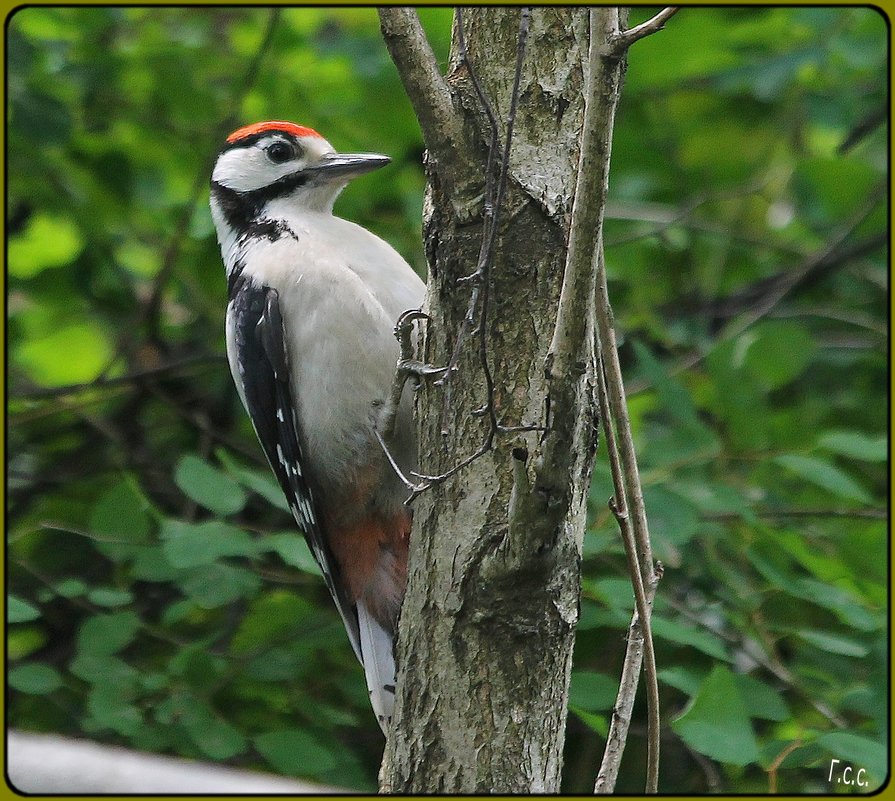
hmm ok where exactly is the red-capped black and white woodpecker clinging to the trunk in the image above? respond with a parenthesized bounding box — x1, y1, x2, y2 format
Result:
(211, 122, 425, 732)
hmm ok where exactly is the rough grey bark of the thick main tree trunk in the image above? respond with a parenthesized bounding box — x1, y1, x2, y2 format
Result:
(381, 7, 597, 793)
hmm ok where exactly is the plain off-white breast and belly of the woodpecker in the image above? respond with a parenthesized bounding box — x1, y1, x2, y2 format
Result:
(233, 212, 425, 504)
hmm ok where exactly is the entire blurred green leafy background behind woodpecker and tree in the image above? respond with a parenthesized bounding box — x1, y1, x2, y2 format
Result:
(6, 7, 889, 793)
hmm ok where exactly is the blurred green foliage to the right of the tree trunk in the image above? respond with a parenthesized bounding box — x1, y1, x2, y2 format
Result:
(567, 8, 888, 792)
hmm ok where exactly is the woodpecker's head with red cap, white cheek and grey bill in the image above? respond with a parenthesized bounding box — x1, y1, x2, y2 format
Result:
(211, 122, 390, 228)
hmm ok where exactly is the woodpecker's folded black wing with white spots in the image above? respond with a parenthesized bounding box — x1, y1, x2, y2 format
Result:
(228, 276, 363, 663)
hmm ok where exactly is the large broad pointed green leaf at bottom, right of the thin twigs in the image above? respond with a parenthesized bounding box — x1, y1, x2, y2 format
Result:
(671, 665, 758, 765)
